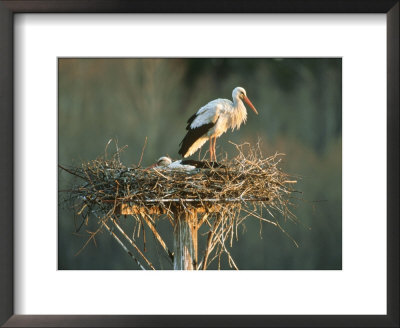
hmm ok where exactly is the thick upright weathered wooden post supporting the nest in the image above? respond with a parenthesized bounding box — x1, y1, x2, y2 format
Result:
(174, 211, 197, 270)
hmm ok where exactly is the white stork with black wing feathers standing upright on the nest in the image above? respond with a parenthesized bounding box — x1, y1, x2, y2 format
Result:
(178, 87, 258, 161)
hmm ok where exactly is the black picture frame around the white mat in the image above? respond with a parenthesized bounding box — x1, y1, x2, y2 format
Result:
(0, 0, 400, 327)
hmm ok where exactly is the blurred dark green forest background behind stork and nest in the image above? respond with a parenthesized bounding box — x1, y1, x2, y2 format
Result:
(58, 58, 342, 270)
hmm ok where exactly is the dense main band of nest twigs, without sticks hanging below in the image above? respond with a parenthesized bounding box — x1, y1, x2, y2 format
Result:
(67, 144, 296, 213)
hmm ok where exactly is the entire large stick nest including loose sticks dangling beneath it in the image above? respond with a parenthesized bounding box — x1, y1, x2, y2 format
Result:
(62, 144, 296, 268)
